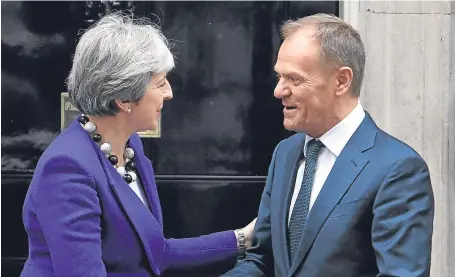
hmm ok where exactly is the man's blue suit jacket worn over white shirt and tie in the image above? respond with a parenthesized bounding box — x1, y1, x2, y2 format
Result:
(223, 114, 434, 277)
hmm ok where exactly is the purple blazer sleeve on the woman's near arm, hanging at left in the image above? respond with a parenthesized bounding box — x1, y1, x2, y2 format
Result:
(34, 155, 107, 277)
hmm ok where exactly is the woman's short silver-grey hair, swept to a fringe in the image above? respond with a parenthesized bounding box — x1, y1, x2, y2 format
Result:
(67, 13, 174, 116)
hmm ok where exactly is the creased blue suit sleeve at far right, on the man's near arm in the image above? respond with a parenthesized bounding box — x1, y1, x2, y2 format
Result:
(372, 157, 434, 277)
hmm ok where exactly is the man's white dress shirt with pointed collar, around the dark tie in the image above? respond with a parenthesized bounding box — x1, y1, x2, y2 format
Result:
(288, 101, 365, 224)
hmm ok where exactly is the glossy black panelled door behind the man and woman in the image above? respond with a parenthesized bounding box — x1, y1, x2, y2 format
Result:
(1, 1, 338, 277)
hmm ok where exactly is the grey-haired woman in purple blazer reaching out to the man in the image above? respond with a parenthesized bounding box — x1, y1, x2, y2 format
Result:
(21, 14, 254, 277)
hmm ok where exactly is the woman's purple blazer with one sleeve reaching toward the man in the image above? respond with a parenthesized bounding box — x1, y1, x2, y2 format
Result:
(21, 121, 237, 277)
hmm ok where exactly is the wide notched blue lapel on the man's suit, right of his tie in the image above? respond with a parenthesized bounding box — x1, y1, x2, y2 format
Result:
(289, 114, 377, 276)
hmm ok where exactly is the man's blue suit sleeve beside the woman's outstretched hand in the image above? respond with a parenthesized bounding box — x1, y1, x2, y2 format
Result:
(222, 141, 279, 277)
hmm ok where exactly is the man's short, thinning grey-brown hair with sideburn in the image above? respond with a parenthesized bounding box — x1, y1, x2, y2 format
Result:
(281, 14, 365, 96)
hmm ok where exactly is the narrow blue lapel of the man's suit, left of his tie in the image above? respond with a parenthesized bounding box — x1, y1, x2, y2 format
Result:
(279, 135, 305, 269)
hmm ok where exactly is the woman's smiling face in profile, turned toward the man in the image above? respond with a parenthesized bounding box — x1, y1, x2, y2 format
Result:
(131, 73, 172, 132)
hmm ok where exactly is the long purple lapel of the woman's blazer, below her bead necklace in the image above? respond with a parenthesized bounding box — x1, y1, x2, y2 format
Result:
(98, 147, 164, 275)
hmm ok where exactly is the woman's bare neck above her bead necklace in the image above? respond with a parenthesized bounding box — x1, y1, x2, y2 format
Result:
(89, 116, 132, 166)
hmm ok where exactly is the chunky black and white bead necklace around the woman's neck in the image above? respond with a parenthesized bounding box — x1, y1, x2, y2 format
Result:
(77, 115, 137, 184)
